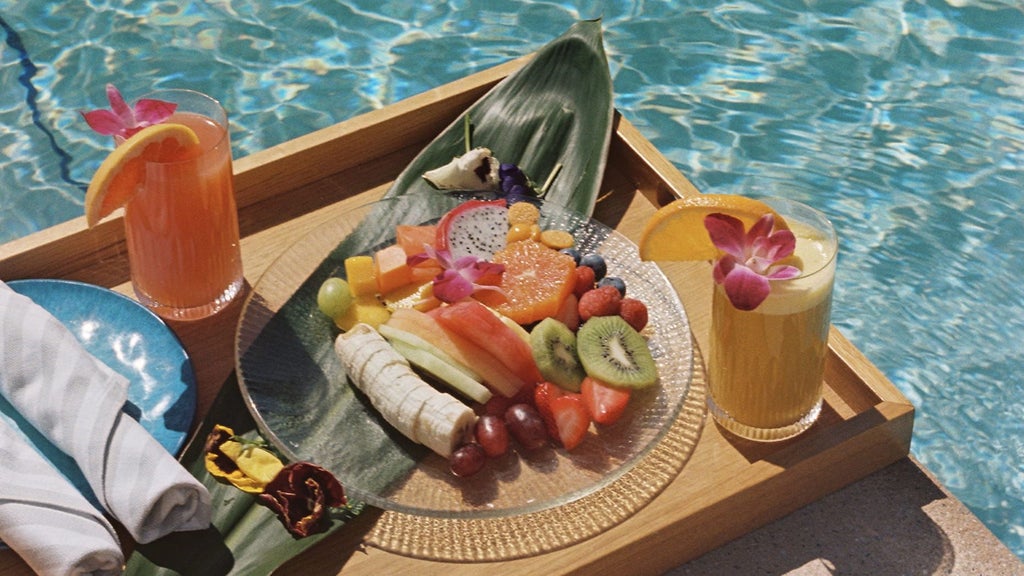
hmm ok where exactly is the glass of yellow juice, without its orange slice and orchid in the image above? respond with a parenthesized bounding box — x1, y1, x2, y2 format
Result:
(708, 198, 839, 441)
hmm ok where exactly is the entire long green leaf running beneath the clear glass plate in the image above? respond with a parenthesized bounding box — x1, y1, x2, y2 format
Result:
(126, 20, 613, 576)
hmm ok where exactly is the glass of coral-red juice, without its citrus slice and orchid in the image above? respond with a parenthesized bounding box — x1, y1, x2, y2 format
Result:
(124, 89, 245, 320)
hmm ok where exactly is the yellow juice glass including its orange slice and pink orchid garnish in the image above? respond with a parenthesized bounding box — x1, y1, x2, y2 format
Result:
(639, 194, 838, 441)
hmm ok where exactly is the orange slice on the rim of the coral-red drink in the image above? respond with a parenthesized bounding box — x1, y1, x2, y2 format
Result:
(85, 124, 199, 228)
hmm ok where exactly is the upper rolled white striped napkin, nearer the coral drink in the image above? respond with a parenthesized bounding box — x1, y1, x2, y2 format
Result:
(0, 282, 211, 543)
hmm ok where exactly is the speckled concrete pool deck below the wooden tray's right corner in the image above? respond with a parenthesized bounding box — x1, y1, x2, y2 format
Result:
(665, 457, 1024, 576)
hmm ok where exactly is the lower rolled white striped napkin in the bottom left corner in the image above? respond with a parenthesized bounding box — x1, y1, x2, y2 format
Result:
(0, 412, 124, 576)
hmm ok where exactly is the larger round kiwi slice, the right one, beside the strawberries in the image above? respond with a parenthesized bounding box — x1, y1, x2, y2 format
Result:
(577, 316, 657, 388)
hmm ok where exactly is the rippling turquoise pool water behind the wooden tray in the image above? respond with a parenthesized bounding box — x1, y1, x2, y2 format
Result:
(0, 0, 1024, 558)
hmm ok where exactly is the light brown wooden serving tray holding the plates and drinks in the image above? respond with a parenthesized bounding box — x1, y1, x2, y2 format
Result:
(0, 54, 913, 575)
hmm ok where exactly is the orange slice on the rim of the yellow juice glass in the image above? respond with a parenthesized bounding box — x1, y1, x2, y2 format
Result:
(640, 194, 788, 261)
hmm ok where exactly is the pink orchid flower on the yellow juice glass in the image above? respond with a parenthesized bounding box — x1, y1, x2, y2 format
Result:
(705, 213, 800, 311)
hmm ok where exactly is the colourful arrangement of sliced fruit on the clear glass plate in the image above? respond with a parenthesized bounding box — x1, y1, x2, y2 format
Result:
(317, 200, 657, 476)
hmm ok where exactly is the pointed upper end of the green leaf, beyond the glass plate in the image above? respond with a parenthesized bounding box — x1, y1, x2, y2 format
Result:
(385, 20, 614, 216)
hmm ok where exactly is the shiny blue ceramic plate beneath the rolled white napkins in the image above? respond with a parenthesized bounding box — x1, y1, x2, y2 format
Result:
(0, 280, 196, 501)
